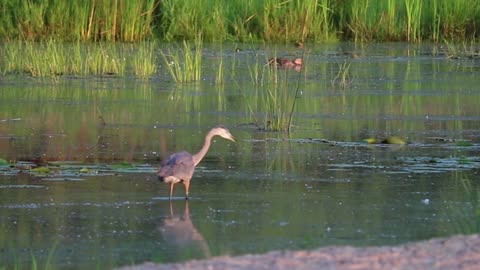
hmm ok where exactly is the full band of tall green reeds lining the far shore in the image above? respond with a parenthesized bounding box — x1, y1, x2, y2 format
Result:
(0, 0, 480, 42)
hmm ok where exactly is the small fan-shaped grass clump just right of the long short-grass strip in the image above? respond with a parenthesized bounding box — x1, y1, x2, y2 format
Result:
(161, 38, 202, 82)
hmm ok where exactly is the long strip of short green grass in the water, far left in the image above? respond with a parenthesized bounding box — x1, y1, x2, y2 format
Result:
(0, 40, 157, 78)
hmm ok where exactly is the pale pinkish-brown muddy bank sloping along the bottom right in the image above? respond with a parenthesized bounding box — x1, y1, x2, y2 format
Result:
(121, 234, 480, 270)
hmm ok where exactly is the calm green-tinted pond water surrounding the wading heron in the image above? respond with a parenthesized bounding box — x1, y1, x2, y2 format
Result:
(0, 43, 480, 269)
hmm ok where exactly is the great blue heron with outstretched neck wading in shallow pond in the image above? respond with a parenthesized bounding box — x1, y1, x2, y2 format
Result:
(157, 126, 235, 200)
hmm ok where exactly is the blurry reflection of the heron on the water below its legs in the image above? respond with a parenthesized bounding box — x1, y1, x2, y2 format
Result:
(158, 201, 210, 259)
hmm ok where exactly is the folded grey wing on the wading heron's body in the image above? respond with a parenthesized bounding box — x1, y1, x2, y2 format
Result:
(157, 151, 195, 180)
